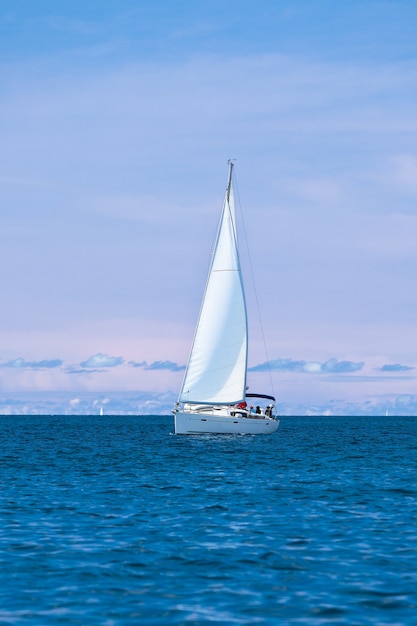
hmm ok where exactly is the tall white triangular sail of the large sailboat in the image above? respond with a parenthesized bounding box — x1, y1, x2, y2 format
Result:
(179, 163, 247, 404)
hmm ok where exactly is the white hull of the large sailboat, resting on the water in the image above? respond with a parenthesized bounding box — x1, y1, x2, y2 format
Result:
(174, 411, 279, 435)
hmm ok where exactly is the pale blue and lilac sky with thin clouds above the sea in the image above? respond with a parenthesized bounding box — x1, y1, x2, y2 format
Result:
(0, 0, 417, 415)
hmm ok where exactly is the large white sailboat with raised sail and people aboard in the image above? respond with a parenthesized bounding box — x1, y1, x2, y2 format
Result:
(173, 161, 279, 435)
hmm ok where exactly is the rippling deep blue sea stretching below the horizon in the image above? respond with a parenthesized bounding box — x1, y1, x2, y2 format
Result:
(0, 416, 417, 626)
